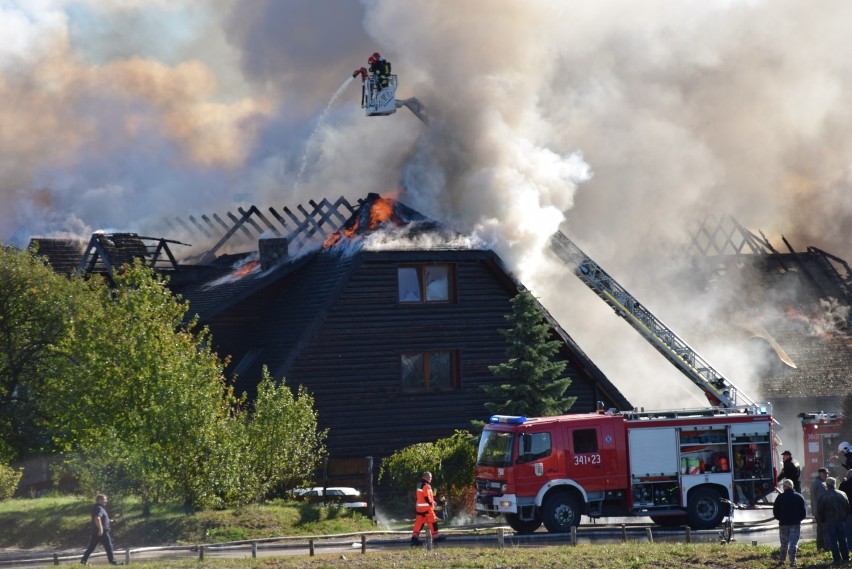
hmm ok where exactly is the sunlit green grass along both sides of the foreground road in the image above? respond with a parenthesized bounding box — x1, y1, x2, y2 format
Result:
(0, 496, 844, 569)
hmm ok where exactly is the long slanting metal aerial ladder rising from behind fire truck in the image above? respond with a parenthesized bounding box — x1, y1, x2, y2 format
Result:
(550, 231, 760, 412)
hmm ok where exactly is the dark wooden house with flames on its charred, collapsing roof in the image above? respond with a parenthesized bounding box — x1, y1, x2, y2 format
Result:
(35, 194, 631, 457)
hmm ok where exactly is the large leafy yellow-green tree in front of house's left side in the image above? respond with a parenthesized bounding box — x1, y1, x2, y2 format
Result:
(45, 262, 242, 507)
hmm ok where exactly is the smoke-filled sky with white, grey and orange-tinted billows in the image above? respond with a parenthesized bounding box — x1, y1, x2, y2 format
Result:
(0, 0, 852, 414)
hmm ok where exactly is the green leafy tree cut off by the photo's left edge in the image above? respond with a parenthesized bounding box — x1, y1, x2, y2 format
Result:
(0, 242, 87, 461)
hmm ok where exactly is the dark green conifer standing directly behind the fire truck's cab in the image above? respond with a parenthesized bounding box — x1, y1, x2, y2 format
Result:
(480, 290, 577, 425)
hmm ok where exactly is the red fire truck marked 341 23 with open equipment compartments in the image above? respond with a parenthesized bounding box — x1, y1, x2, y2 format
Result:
(476, 407, 776, 533)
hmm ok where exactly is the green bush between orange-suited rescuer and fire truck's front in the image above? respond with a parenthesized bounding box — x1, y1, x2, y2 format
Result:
(379, 431, 476, 510)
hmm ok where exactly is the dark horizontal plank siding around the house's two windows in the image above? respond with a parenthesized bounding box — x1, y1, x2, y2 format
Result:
(285, 255, 612, 456)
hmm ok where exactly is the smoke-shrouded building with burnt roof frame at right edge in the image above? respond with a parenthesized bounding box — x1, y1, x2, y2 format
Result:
(681, 217, 852, 423)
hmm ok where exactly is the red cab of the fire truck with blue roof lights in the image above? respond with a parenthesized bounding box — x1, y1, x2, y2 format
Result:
(476, 414, 628, 533)
